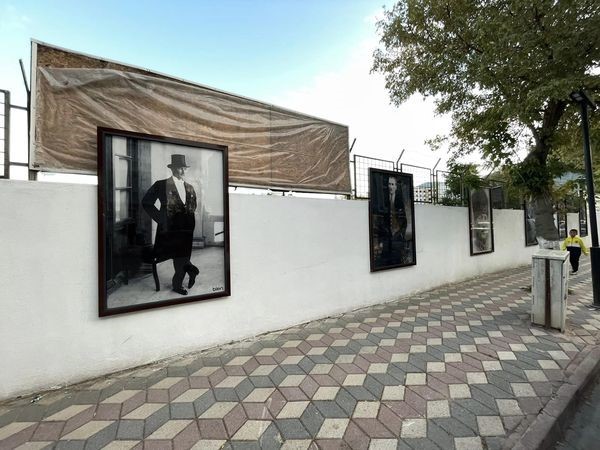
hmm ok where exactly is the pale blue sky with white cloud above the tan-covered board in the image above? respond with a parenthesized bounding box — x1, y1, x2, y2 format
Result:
(0, 0, 450, 183)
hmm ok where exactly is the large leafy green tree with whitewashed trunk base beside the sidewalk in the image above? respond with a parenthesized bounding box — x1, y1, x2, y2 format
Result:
(373, 0, 600, 246)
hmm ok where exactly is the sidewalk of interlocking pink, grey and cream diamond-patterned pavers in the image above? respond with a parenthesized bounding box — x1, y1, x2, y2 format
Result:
(0, 263, 600, 450)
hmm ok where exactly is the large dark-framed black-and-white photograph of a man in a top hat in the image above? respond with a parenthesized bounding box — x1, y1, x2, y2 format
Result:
(98, 128, 231, 316)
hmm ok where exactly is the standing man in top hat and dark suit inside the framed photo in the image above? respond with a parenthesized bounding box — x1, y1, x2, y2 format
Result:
(142, 154, 200, 295)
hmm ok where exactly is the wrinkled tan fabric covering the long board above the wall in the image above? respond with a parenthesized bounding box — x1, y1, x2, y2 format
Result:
(33, 44, 350, 193)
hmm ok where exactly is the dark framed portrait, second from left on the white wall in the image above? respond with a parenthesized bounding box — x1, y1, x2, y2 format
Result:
(369, 168, 417, 272)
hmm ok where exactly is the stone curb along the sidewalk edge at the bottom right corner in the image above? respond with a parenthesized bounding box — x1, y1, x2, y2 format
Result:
(505, 346, 600, 450)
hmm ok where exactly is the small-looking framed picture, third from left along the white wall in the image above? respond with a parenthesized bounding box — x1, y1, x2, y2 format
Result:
(469, 189, 494, 256)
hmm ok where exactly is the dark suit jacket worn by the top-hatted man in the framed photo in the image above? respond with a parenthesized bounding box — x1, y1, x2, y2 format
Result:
(142, 177, 197, 261)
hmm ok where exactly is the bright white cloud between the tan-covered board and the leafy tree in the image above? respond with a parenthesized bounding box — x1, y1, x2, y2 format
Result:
(264, 34, 450, 172)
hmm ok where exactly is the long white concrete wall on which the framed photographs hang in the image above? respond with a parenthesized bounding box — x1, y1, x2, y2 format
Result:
(0, 180, 592, 398)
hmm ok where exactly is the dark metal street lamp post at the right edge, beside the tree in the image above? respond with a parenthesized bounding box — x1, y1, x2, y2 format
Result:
(571, 90, 600, 308)
